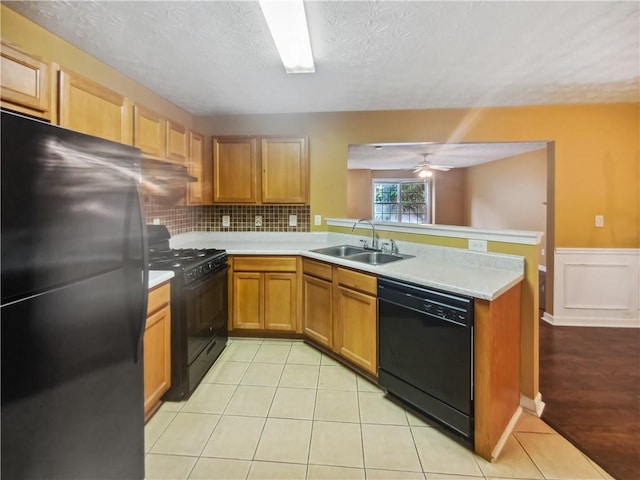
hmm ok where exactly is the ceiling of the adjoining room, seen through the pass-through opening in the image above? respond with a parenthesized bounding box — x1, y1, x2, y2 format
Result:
(348, 142, 547, 170)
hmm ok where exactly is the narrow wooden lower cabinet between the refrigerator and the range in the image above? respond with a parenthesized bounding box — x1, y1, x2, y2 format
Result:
(143, 283, 171, 420)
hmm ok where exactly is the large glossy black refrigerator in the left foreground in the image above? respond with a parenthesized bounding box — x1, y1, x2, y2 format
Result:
(0, 111, 148, 480)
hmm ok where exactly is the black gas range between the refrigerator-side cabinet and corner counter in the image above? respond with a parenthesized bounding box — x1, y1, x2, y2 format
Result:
(147, 225, 229, 401)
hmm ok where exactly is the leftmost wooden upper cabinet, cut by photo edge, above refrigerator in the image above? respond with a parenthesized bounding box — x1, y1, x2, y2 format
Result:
(0, 42, 51, 120)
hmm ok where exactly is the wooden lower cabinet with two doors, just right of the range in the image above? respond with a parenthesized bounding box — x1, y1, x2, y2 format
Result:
(230, 256, 300, 332)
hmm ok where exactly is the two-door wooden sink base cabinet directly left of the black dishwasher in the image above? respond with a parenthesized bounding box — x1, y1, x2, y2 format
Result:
(302, 259, 378, 376)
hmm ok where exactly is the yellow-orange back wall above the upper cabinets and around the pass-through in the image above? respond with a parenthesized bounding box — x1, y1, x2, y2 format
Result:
(196, 104, 640, 248)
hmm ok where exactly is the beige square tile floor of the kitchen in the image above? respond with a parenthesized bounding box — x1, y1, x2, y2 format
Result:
(145, 339, 611, 480)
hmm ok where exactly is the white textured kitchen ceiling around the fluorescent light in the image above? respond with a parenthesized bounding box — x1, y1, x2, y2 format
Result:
(3, 1, 640, 115)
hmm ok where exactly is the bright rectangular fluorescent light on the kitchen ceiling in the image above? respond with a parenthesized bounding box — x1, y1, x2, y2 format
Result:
(260, 0, 316, 73)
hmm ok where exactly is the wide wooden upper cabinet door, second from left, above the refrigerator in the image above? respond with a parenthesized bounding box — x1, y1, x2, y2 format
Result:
(58, 70, 131, 145)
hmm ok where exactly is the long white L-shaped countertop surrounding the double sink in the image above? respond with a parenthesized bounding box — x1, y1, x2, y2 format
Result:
(171, 232, 524, 300)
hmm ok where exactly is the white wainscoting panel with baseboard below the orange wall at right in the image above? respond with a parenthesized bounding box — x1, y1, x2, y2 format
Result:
(544, 248, 640, 328)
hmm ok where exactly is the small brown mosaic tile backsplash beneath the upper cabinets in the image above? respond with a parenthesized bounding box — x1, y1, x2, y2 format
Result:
(144, 195, 311, 235)
